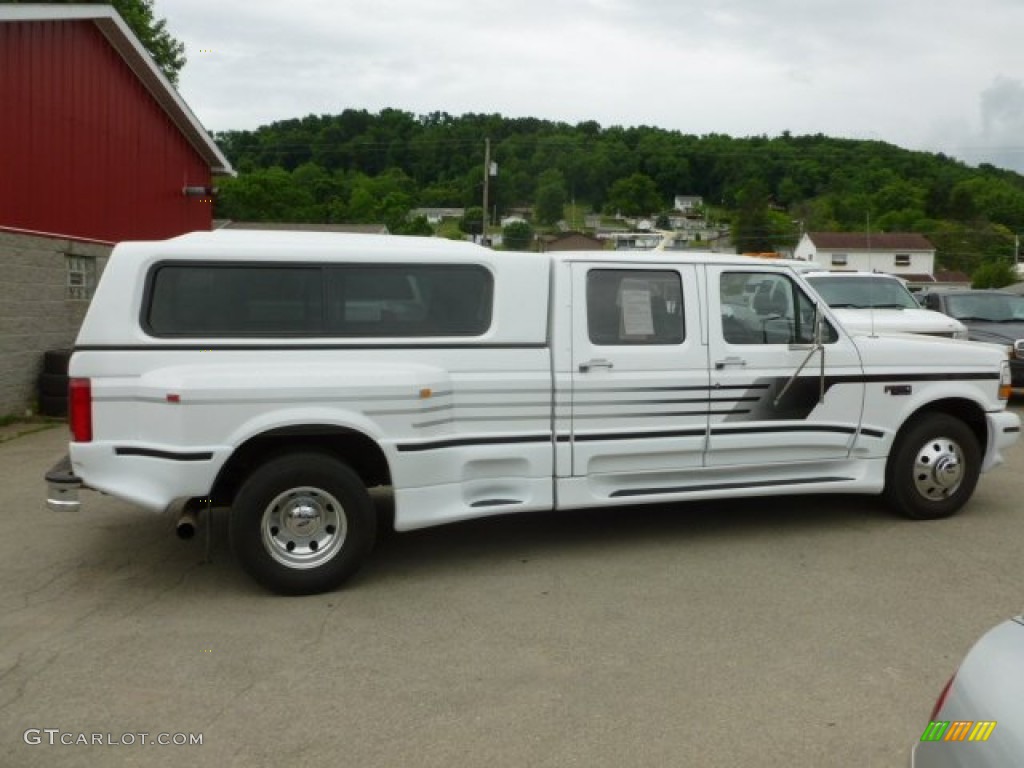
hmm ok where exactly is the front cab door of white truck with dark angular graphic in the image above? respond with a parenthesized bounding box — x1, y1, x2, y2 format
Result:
(703, 265, 864, 468)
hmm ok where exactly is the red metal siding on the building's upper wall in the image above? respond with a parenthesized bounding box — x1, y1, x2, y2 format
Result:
(0, 22, 212, 241)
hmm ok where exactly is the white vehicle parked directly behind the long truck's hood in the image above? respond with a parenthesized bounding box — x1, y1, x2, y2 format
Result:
(804, 271, 968, 339)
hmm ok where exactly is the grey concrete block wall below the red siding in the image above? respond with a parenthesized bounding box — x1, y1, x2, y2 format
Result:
(0, 231, 111, 417)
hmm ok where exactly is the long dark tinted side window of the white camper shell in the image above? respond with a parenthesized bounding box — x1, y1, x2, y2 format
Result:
(141, 261, 494, 338)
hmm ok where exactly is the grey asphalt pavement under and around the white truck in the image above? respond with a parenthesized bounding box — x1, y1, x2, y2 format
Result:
(0, 406, 1024, 768)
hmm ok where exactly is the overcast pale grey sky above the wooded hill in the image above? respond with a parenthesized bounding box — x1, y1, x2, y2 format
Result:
(165, 0, 1024, 172)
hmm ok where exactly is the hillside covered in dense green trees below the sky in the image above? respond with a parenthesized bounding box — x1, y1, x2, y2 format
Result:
(215, 110, 1024, 272)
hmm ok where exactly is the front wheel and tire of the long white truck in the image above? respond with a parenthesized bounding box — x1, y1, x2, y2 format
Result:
(884, 414, 981, 520)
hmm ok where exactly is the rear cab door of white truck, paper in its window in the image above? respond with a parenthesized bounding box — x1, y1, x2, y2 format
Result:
(563, 261, 709, 493)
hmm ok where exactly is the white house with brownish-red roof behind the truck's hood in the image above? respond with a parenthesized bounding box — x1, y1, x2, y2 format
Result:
(794, 232, 935, 282)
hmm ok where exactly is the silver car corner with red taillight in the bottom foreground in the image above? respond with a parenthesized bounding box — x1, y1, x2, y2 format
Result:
(910, 616, 1024, 768)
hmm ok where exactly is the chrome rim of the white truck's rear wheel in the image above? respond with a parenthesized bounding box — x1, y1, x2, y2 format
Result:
(260, 486, 348, 569)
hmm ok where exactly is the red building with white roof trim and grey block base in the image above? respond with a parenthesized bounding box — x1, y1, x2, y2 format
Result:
(0, 4, 233, 415)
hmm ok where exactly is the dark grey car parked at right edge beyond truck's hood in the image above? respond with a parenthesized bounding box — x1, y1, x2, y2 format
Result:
(924, 290, 1024, 389)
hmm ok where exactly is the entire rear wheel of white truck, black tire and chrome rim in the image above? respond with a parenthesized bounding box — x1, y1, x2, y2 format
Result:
(229, 452, 377, 595)
